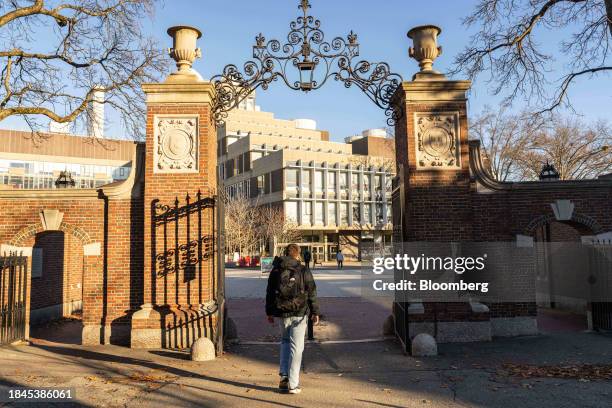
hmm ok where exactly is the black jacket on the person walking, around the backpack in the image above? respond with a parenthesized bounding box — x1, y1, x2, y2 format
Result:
(266, 256, 320, 317)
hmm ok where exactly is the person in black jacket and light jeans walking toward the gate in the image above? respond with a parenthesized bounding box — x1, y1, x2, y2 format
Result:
(266, 244, 320, 394)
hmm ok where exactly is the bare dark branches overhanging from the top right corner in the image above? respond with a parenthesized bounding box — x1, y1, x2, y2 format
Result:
(454, 0, 612, 113)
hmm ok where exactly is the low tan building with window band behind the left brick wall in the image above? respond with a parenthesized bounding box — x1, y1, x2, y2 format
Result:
(0, 130, 136, 189)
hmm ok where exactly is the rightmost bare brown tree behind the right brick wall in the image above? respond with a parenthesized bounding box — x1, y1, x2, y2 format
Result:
(523, 118, 612, 180)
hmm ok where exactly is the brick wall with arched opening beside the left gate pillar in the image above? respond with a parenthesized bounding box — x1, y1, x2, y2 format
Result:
(0, 186, 143, 344)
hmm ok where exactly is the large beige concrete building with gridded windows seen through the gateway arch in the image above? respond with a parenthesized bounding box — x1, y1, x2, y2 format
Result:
(218, 97, 395, 260)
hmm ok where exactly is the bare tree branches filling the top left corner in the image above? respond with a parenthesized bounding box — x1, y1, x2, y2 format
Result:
(0, 0, 166, 142)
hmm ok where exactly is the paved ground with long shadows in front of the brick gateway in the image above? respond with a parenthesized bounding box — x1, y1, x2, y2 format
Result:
(0, 333, 612, 408)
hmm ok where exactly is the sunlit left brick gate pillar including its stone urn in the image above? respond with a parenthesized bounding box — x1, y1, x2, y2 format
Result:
(131, 27, 217, 348)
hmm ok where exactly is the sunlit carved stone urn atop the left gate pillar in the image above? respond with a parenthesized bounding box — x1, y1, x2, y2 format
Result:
(168, 26, 202, 79)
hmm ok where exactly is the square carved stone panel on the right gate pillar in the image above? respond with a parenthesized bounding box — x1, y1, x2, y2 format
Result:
(414, 112, 461, 170)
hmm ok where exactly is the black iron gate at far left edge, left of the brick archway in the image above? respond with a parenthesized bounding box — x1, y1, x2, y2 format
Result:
(0, 255, 28, 345)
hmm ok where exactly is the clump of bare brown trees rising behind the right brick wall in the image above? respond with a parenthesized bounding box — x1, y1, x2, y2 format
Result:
(470, 108, 612, 181)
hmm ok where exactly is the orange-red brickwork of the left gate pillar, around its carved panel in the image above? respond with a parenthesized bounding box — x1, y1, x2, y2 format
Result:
(141, 103, 217, 347)
